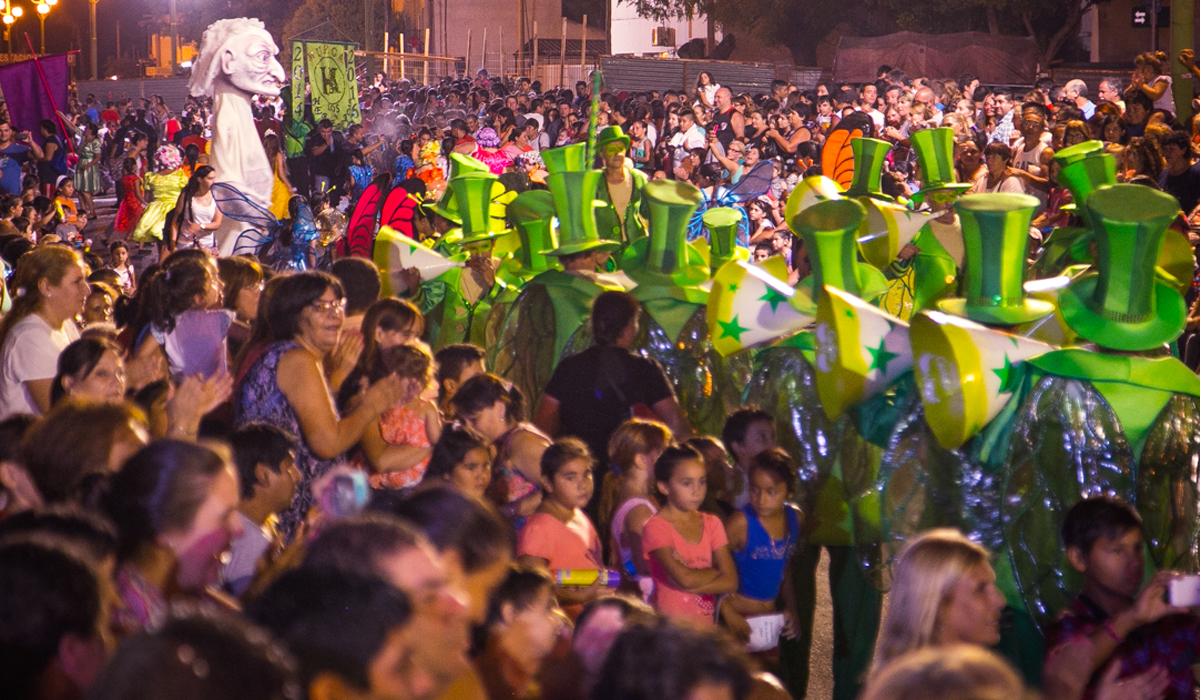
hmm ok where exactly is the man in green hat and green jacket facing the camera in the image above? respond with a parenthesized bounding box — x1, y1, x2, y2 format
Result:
(596, 126, 647, 245)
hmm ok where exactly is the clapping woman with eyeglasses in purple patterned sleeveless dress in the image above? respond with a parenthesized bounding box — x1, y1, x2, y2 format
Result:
(234, 273, 413, 538)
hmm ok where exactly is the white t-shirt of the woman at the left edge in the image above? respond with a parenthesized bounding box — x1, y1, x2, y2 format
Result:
(0, 313, 79, 420)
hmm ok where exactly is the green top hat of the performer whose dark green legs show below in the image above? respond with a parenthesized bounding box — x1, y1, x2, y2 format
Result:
(791, 194, 887, 315)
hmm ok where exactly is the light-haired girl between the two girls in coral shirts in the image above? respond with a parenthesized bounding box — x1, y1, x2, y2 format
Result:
(598, 418, 674, 594)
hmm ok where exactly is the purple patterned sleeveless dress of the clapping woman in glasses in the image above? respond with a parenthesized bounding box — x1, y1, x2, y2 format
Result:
(234, 340, 337, 540)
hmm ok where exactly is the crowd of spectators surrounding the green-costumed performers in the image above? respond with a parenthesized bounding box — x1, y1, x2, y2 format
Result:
(0, 43, 1200, 700)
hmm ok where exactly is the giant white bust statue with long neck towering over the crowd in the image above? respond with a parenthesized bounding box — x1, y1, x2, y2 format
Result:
(188, 17, 287, 255)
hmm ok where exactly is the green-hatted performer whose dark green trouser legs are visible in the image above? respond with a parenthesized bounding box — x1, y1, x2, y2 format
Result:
(744, 194, 884, 700)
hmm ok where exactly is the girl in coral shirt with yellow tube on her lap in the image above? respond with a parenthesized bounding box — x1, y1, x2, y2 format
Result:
(517, 437, 607, 617)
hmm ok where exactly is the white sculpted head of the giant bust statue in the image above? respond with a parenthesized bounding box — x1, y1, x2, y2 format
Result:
(188, 17, 287, 97)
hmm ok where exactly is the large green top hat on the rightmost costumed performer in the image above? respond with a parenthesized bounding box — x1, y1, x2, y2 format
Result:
(1058, 185, 1187, 351)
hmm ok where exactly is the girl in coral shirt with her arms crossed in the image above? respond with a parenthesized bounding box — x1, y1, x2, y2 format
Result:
(642, 445, 738, 627)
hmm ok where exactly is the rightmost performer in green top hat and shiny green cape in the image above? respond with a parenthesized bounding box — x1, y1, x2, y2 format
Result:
(940, 185, 1200, 677)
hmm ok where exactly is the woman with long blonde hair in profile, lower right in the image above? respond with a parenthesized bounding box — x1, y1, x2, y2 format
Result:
(872, 528, 1004, 675)
